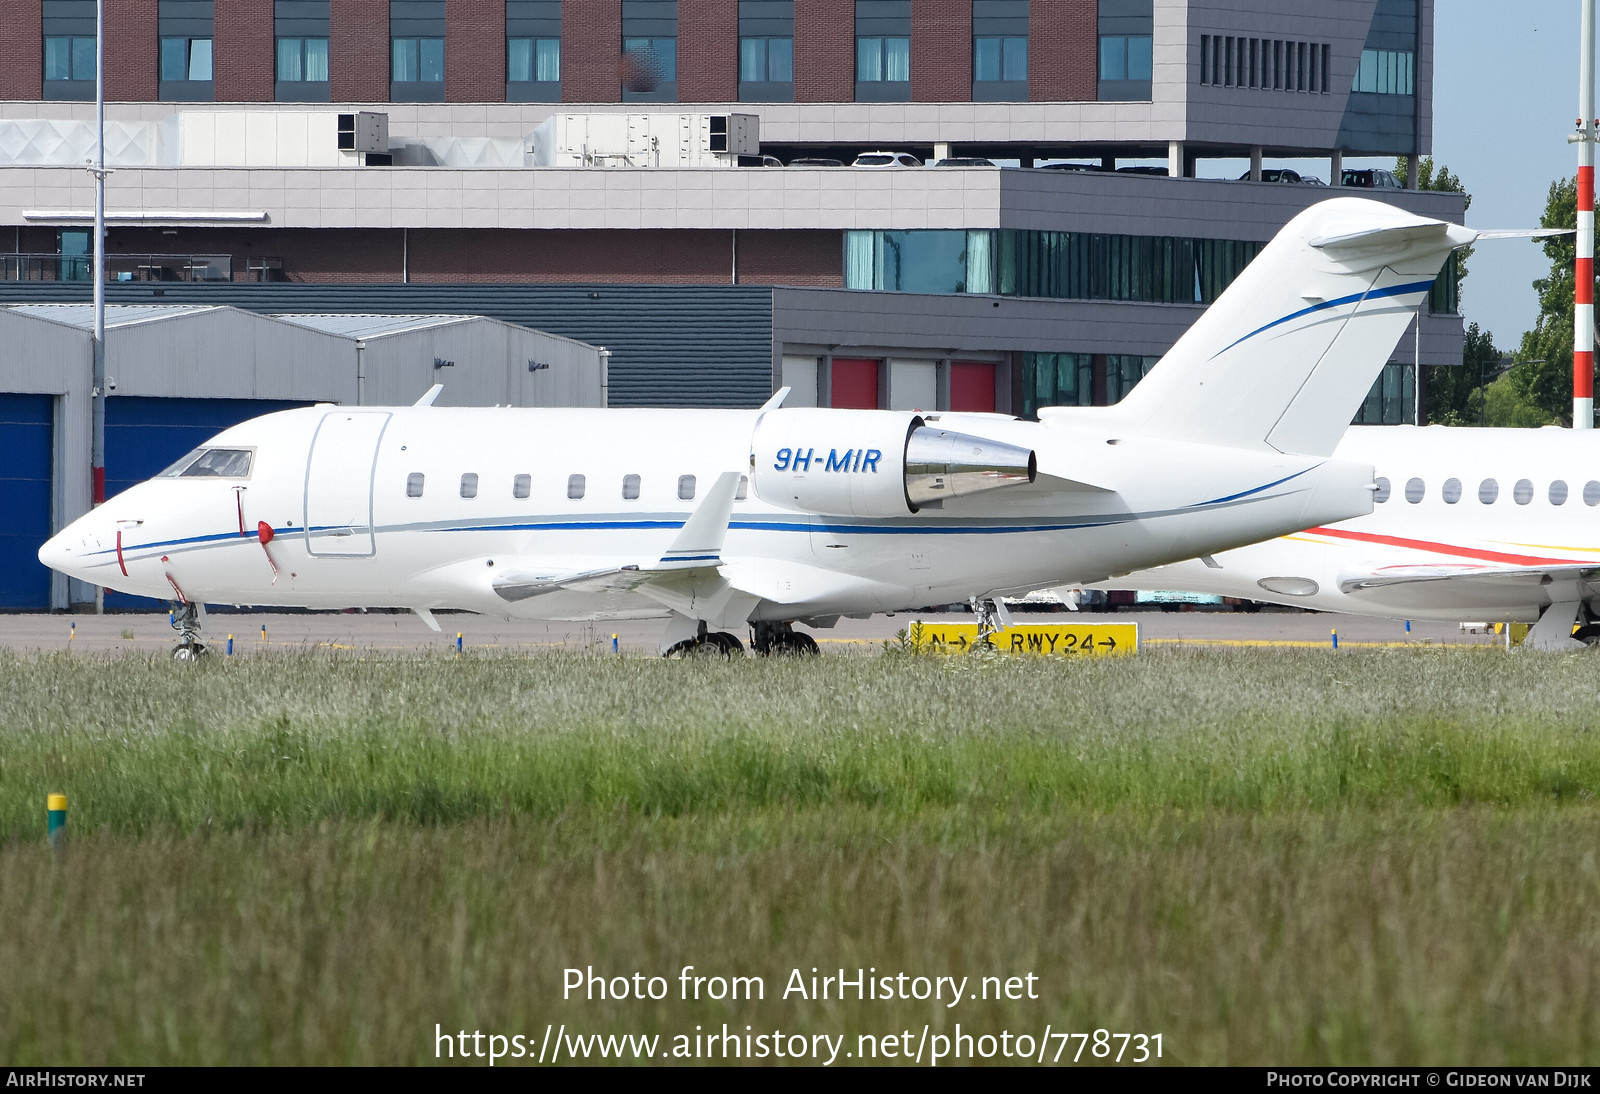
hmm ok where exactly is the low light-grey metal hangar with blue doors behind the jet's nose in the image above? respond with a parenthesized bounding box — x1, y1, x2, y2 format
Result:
(0, 304, 606, 611)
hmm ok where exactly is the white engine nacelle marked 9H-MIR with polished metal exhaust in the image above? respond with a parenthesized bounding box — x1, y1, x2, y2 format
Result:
(750, 406, 1038, 517)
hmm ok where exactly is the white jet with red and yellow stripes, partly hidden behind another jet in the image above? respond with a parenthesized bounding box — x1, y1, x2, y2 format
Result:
(1088, 425, 1600, 649)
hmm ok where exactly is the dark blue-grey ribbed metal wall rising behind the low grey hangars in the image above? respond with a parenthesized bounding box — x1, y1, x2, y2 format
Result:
(5, 281, 773, 406)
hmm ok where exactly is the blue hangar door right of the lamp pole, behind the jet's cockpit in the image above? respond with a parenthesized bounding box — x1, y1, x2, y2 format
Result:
(106, 395, 309, 611)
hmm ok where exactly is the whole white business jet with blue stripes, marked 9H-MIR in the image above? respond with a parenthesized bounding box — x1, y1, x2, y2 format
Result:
(38, 198, 1477, 659)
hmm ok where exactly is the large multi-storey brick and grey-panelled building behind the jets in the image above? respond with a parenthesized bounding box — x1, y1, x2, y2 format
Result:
(0, 0, 1464, 608)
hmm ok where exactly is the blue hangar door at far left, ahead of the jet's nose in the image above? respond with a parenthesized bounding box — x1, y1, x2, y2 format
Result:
(0, 395, 54, 611)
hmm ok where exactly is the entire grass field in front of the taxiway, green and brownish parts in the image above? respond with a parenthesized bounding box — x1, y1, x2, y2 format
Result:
(0, 649, 1600, 1064)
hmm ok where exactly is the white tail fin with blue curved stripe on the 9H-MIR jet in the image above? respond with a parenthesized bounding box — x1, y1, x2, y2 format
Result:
(1115, 198, 1477, 456)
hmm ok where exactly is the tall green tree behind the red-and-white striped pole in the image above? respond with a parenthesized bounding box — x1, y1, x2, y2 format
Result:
(1510, 179, 1600, 425)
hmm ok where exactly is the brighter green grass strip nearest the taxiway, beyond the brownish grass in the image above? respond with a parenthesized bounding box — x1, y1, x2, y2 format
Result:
(0, 651, 1600, 843)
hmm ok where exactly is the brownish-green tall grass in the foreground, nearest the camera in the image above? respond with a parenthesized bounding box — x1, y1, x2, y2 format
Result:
(0, 806, 1600, 1065)
